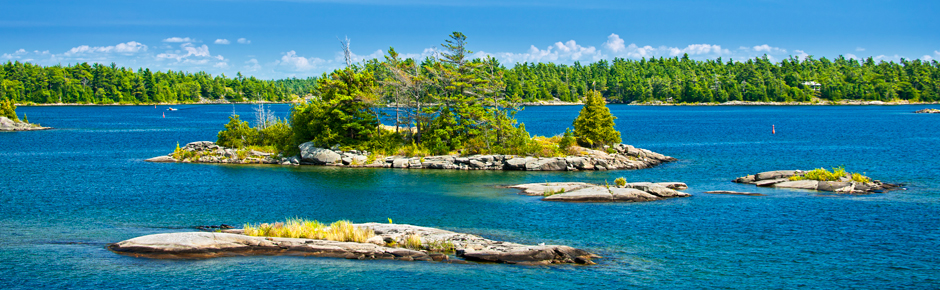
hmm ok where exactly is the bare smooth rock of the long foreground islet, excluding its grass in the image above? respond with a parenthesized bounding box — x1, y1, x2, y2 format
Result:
(108, 223, 600, 265)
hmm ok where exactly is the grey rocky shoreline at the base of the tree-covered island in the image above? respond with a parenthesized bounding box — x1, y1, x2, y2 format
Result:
(146, 141, 676, 171)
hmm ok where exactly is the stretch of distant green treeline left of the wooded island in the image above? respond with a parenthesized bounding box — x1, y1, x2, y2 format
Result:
(0, 62, 315, 104)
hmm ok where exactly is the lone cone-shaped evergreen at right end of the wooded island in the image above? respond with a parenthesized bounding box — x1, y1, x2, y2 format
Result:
(574, 91, 620, 148)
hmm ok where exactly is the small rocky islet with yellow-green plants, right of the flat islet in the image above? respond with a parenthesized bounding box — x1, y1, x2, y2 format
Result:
(734, 168, 900, 194)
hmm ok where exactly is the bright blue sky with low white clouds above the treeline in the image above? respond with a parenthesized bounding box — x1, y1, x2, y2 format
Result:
(0, 0, 940, 79)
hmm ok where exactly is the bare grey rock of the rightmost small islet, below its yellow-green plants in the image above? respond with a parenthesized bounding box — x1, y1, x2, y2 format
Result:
(734, 170, 901, 194)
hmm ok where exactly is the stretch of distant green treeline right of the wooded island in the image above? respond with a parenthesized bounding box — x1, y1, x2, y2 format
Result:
(492, 55, 940, 103)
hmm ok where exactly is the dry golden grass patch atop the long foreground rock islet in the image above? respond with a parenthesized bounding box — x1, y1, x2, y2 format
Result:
(244, 218, 375, 243)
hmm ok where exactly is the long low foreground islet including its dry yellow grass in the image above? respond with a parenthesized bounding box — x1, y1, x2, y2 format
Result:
(108, 219, 600, 265)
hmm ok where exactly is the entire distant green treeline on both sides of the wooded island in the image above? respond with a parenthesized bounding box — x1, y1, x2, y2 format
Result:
(0, 55, 940, 104)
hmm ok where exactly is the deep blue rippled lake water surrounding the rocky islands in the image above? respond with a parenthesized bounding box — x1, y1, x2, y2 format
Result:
(0, 105, 940, 289)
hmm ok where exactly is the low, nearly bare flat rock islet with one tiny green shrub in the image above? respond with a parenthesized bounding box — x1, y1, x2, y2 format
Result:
(508, 182, 691, 202)
